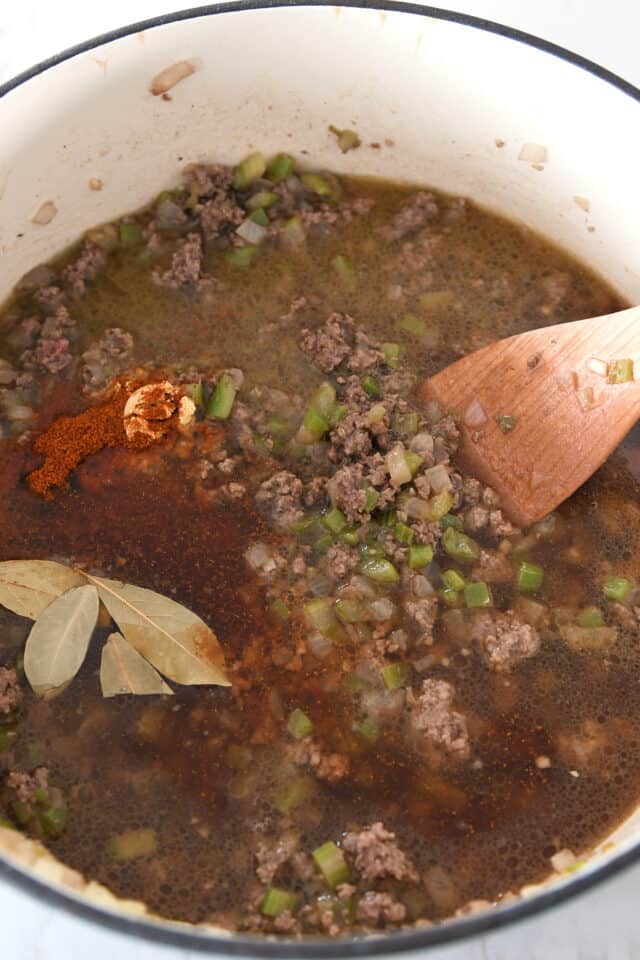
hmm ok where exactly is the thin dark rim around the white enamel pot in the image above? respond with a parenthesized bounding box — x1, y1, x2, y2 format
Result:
(0, 0, 640, 958)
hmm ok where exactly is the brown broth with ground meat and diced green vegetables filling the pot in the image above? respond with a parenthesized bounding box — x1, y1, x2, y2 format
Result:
(0, 159, 640, 935)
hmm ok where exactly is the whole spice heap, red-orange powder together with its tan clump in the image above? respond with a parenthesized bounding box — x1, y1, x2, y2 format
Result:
(27, 380, 195, 500)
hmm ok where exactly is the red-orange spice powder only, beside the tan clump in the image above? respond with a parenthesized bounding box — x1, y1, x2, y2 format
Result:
(27, 384, 171, 500)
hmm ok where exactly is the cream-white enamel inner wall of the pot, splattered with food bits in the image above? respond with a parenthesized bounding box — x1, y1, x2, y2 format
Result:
(0, 2, 640, 956)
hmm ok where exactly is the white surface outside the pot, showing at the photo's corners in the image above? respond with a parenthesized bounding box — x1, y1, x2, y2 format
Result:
(0, 0, 640, 960)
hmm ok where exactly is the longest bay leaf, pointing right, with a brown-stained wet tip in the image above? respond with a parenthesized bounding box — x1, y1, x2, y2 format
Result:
(83, 573, 230, 687)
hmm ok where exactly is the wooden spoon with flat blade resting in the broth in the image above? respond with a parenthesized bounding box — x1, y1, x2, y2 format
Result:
(418, 307, 640, 526)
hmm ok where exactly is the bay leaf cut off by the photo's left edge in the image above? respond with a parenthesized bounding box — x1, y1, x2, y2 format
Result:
(0, 560, 86, 620)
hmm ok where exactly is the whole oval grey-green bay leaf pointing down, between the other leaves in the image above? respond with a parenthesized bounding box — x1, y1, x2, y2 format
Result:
(24, 584, 99, 699)
